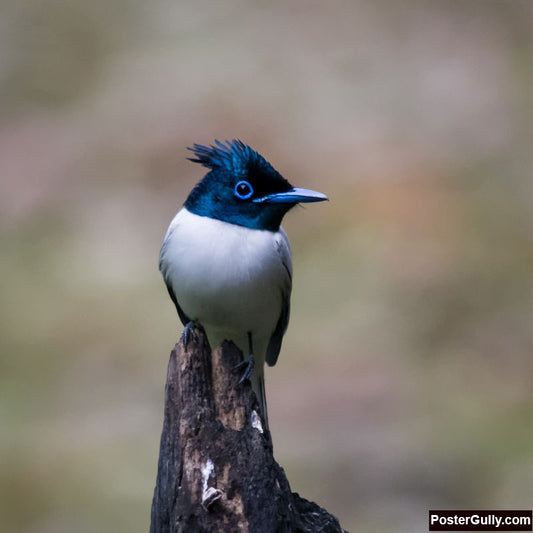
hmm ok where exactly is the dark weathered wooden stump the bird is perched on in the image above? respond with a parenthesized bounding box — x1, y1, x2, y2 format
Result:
(150, 328, 350, 533)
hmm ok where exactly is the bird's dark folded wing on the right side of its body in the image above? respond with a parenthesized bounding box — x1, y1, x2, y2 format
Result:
(266, 228, 292, 366)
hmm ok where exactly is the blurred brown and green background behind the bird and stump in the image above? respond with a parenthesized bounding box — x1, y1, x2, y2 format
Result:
(0, 0, 533, 533)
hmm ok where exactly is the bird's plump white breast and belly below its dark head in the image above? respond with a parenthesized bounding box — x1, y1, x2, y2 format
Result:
(160, 208, 292, 356)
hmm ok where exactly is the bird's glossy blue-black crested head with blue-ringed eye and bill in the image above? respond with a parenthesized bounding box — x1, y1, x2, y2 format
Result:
(185, 140, 328, 231)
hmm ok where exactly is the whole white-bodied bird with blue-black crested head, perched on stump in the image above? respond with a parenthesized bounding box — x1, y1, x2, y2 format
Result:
(159, 139, 328, 428)
